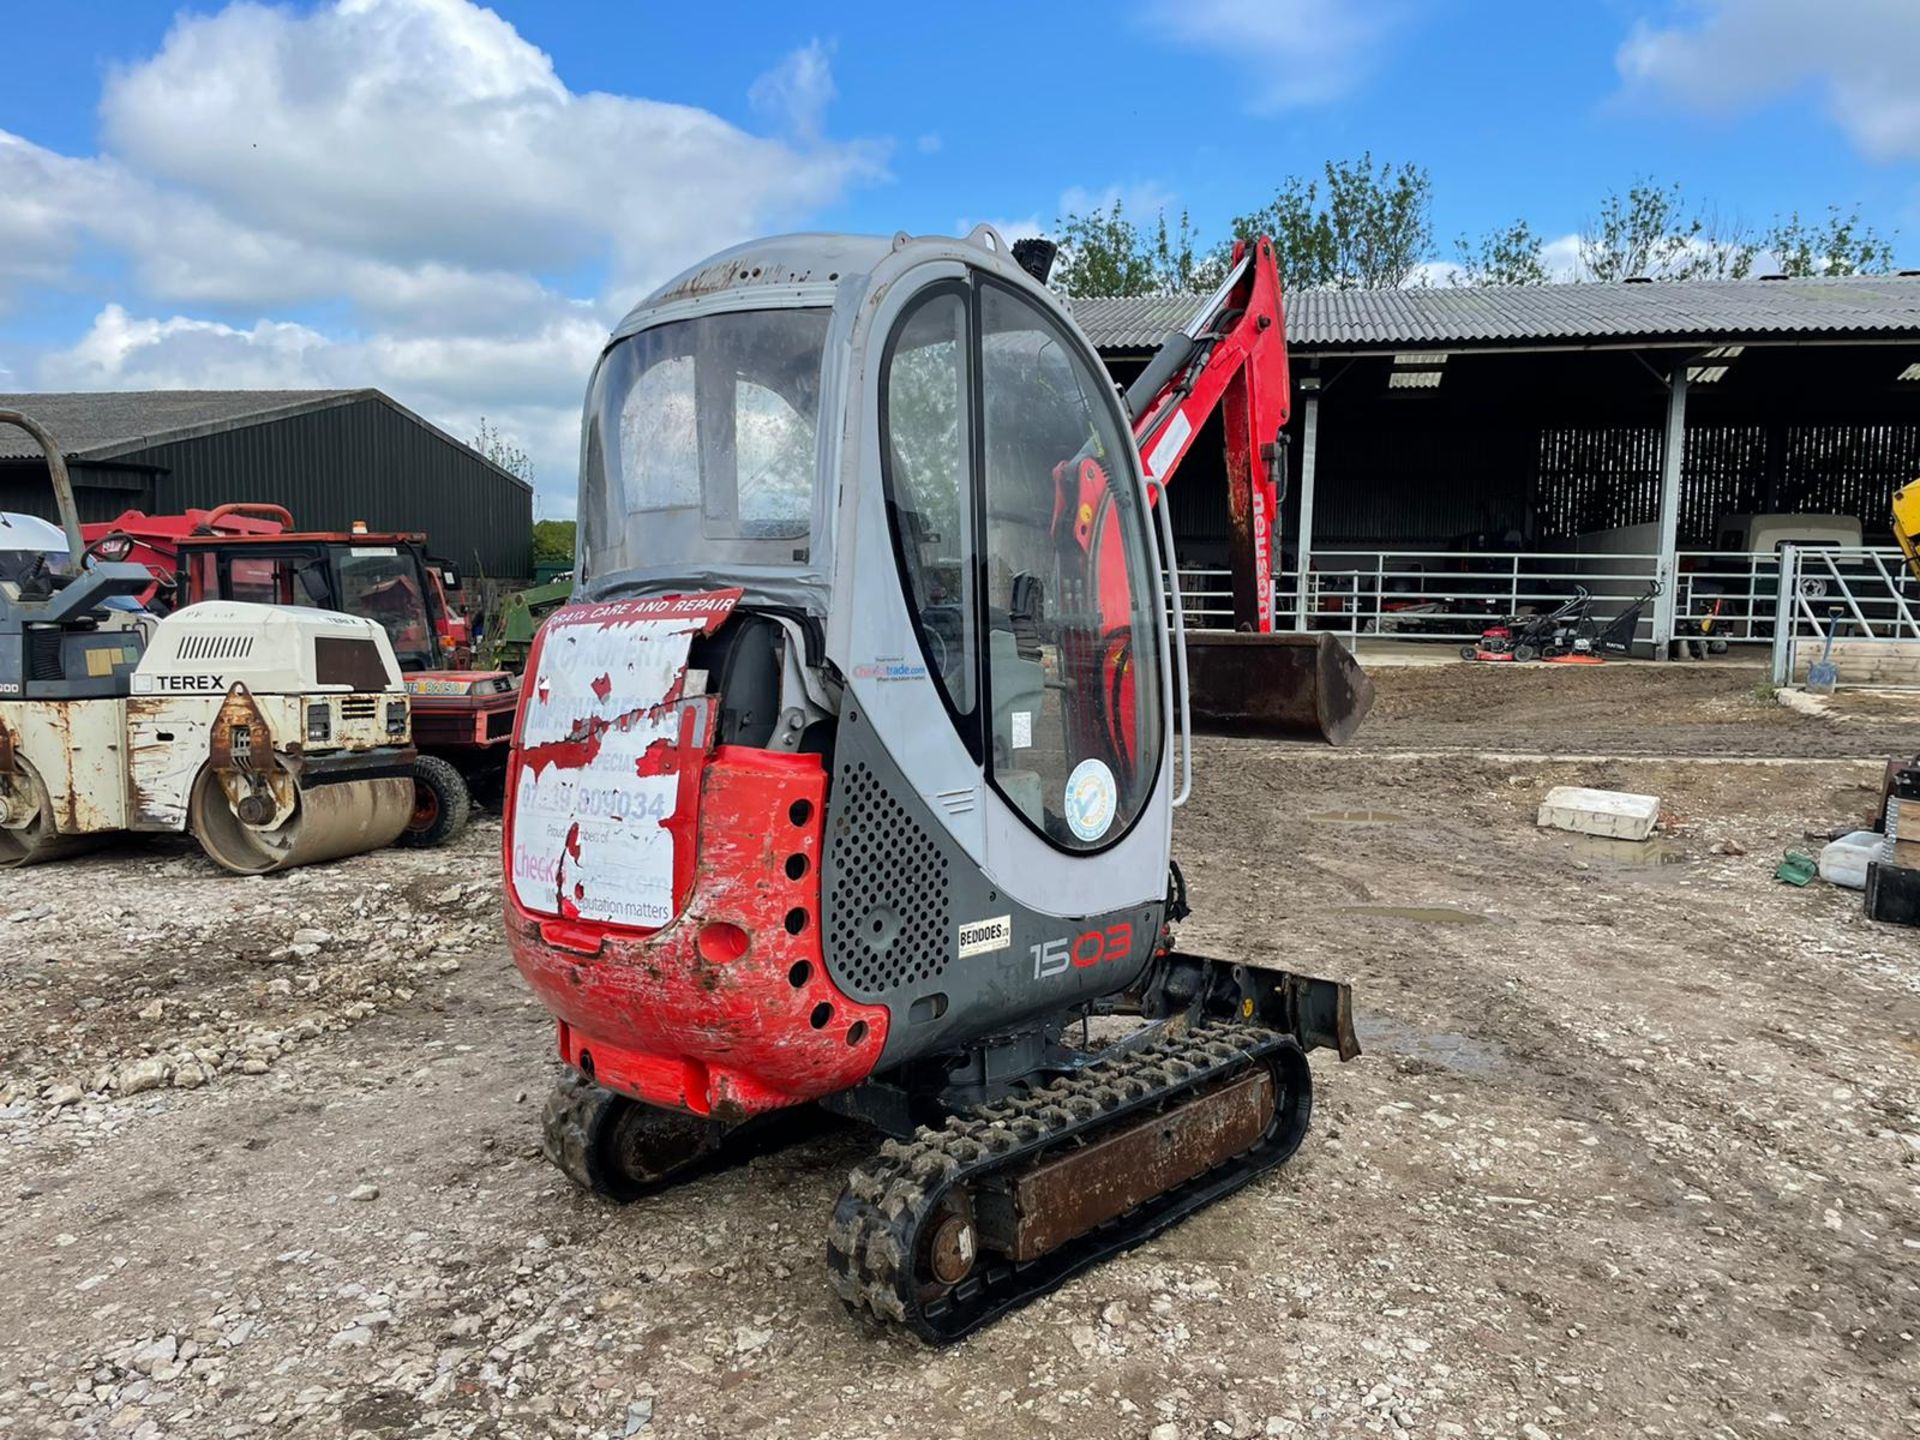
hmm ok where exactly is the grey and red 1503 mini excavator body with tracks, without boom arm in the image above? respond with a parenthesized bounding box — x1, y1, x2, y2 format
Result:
(505, 227, 1357, 1340)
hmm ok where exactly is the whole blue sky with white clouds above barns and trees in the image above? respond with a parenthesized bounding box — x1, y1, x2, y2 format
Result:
(0, 0, 1920, 513)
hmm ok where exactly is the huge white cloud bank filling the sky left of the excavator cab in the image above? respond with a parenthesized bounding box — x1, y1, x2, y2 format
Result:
(0, 0, 885, 509)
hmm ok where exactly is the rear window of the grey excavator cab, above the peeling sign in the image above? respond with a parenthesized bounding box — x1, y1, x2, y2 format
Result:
(580, 309, 829, 576)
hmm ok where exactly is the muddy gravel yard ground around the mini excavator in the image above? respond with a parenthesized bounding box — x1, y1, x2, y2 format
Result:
(0, 672, 1920, 1440)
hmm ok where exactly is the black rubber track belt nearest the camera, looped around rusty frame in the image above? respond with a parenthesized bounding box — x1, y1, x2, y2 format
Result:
(828, 1023, 1311, 1344)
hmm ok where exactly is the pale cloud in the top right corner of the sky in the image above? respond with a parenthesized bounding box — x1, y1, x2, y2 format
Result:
(1615, 0, 1920, 159)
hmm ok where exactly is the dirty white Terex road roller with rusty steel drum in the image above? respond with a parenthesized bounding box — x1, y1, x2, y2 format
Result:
(0, 411, 415, 876)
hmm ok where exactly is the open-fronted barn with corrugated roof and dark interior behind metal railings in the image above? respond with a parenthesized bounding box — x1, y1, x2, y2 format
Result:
(1075, 276, 1920, 648)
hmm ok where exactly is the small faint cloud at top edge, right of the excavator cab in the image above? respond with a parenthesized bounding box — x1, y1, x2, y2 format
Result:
(1144, 0, 1407, 111)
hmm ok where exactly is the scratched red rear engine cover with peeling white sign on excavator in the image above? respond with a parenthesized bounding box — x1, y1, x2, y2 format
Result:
(505, 591, 887, 1117)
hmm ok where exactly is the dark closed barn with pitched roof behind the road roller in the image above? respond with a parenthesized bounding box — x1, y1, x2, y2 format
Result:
(0, 390, 534, 580)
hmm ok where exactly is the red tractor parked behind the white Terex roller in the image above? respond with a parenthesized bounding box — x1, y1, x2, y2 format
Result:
(81, 503, 518, 845)
